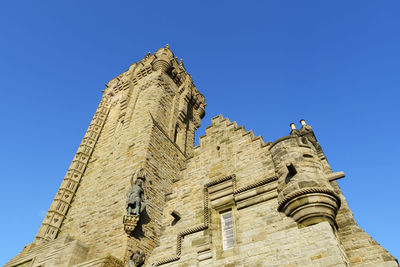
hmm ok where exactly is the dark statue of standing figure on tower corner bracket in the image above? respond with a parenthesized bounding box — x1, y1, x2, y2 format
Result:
(126, 177, 146, 216)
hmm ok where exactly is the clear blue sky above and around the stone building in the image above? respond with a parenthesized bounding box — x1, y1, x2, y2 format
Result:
(0, 0, 400, 265)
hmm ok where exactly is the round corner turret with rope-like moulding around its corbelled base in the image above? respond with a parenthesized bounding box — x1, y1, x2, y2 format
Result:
(270, 127, 340, 227)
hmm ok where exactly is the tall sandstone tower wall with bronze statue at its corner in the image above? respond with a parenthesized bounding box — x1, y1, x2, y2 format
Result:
(5, 47, 205, 266)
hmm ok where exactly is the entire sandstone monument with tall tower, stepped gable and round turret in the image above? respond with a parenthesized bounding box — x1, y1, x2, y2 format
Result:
(5, 46, 398, 267)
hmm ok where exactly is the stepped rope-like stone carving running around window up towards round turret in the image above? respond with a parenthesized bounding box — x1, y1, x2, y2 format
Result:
(153, 175, 278, 266)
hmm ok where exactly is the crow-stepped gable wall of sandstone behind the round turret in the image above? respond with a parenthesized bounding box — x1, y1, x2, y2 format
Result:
(147, 116, 398, 266)
